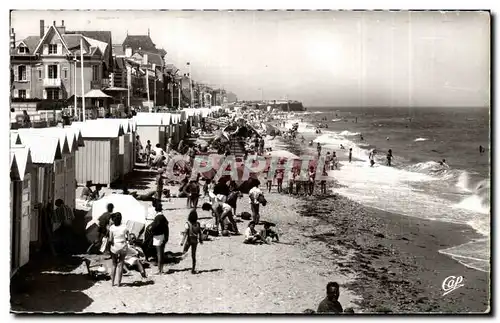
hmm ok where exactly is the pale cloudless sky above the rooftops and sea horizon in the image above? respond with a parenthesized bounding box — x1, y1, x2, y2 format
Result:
(11, 11, 490, 107)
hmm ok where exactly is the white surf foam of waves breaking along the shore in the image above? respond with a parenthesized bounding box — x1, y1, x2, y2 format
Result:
(292, 120, 490, 271)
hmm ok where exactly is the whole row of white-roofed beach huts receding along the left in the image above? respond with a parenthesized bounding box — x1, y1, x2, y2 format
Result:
(10, 107, 221, 276)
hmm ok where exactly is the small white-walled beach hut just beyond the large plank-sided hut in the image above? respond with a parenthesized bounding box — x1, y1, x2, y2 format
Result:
(134, 113, 166, 149)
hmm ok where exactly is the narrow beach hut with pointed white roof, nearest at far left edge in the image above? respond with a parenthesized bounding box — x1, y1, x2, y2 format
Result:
(10, 145, 34, 277)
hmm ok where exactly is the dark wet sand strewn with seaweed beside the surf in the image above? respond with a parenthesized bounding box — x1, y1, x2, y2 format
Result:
(272, 121, 490, 313)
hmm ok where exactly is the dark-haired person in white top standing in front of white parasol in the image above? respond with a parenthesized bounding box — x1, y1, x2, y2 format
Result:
(109, 212, 129, 287)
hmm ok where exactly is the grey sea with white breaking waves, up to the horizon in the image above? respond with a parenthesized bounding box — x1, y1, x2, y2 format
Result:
(286, 108, 491, 272)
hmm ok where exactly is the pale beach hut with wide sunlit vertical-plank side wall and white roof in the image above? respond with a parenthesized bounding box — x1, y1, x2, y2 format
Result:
(71, 121, 123, 187)
